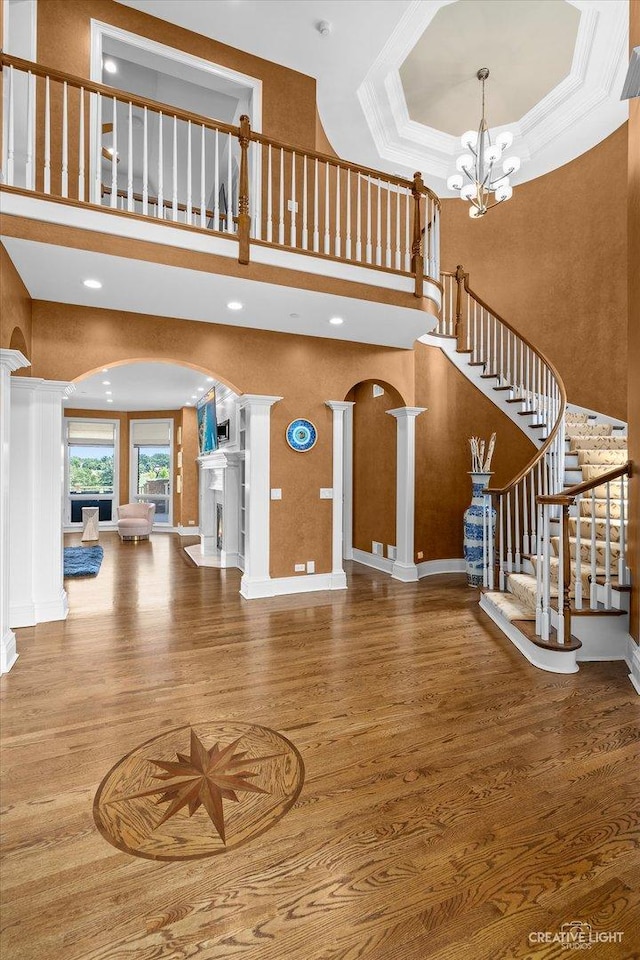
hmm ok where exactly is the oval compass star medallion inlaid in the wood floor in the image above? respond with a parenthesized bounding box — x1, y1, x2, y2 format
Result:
(93, 721, 304, 860)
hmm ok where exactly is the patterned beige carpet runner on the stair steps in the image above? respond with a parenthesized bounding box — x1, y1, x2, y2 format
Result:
(489, 412, 628, 622)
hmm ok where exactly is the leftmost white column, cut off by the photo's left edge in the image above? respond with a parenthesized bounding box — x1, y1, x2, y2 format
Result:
(0, 350, 29, 673)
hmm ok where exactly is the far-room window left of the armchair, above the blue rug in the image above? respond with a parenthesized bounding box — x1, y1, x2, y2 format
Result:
(66, 419, 118, 523)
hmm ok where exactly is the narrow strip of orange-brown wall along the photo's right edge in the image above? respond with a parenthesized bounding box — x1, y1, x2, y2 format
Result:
(628, 0, 640, 641)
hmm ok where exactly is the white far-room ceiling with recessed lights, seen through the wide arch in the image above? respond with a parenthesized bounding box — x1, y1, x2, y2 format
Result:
(67, 363, 219, 411)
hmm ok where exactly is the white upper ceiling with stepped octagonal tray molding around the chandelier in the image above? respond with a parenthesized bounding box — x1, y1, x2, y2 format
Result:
(112, 0, 628, 195)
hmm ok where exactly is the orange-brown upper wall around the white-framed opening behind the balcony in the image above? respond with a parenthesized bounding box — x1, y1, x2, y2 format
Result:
(38, 0, 316, 150)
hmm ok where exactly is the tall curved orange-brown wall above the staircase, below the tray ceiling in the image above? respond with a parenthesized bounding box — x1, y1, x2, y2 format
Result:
(442, 125, 627, 419)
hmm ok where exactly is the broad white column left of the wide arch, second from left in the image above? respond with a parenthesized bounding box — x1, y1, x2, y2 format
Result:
(10, 378, 74, 626)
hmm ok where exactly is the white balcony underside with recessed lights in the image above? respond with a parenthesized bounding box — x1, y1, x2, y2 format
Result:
(2, 237, 433, 349)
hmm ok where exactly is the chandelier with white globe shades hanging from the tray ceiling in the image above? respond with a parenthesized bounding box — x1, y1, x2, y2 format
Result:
(447, 67, 520, 220)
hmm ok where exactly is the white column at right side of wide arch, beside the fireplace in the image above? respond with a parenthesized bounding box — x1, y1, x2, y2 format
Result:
(238, 394, 282, 600)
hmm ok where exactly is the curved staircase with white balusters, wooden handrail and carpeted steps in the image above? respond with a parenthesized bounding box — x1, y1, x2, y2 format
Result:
(421, 267, 640, 692)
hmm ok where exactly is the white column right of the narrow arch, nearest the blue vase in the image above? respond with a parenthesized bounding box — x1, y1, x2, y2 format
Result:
(387, 407, 426, 582)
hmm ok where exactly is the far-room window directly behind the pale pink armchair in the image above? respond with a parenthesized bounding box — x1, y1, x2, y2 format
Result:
(131, 420, 173, 524)
